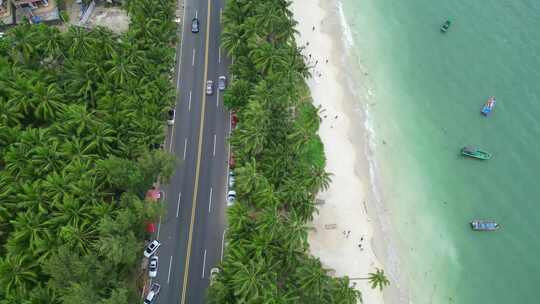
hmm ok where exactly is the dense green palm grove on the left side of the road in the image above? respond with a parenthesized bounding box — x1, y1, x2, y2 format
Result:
(0, 0, 176, 304)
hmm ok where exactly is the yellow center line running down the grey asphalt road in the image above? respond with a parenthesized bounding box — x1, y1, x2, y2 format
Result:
(180, 0, 211, 304)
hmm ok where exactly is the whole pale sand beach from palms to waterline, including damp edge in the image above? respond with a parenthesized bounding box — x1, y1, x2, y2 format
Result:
(291, 0, 407, 304)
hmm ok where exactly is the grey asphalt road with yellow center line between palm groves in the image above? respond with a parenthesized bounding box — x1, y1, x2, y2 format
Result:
(153, 0, 230, 304)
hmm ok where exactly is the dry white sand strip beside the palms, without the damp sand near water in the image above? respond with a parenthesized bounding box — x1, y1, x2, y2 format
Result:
(291, 0, 384, 304)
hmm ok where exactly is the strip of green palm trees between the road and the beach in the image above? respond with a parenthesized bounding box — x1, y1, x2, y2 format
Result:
(208, 0, 360, 304)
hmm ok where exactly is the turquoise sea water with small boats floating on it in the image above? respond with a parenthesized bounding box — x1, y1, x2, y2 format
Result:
(341, 0, 540, 304)
